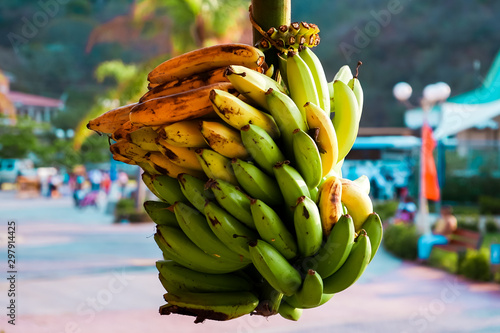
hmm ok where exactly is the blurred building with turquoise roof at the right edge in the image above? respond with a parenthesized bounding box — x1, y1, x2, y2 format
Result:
(405, 52, 500, 177)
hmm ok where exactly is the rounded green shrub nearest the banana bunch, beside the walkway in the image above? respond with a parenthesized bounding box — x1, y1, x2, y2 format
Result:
(383, 224, 420, 260)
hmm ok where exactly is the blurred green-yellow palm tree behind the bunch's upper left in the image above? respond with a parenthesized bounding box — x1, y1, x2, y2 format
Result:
(74, 0, 251, 149)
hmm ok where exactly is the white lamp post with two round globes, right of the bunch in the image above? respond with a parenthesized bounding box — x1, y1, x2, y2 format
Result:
(392, 82, 451, 233)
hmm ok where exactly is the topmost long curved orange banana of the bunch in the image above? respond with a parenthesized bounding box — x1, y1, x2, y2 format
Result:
(148, 44, 264, 83)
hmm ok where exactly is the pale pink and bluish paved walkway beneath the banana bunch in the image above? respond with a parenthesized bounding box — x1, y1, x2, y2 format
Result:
(0, 192, 500, 333)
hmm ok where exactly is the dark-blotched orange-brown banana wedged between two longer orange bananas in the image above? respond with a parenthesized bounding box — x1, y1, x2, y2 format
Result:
(139, 67, 228, 103)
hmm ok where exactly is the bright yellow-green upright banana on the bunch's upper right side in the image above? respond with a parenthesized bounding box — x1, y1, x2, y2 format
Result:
(332, 81, 359, 161)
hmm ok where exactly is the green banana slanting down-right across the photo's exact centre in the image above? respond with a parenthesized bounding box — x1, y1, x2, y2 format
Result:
(231, 159, 283, 205)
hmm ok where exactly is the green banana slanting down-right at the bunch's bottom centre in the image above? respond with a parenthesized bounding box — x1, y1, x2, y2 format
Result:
(250, 239, 302, 296)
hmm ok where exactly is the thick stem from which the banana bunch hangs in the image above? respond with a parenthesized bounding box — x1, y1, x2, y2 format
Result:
(250, 0, 292, 68)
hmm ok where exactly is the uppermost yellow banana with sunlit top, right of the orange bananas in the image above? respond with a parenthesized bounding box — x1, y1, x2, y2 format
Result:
(224, 65, 286, 110)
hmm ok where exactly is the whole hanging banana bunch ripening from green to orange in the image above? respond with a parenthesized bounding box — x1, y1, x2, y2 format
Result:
(88, 40, 382, 322)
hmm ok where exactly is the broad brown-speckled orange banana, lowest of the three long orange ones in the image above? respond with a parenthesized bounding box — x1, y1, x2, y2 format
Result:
(130, 82, 232, 126)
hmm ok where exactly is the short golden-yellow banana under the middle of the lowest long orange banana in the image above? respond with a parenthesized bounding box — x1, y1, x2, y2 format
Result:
(158, 120, 208, 148)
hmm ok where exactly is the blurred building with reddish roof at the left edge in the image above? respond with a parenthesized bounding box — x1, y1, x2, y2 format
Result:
(0, 71, 64, 122)
